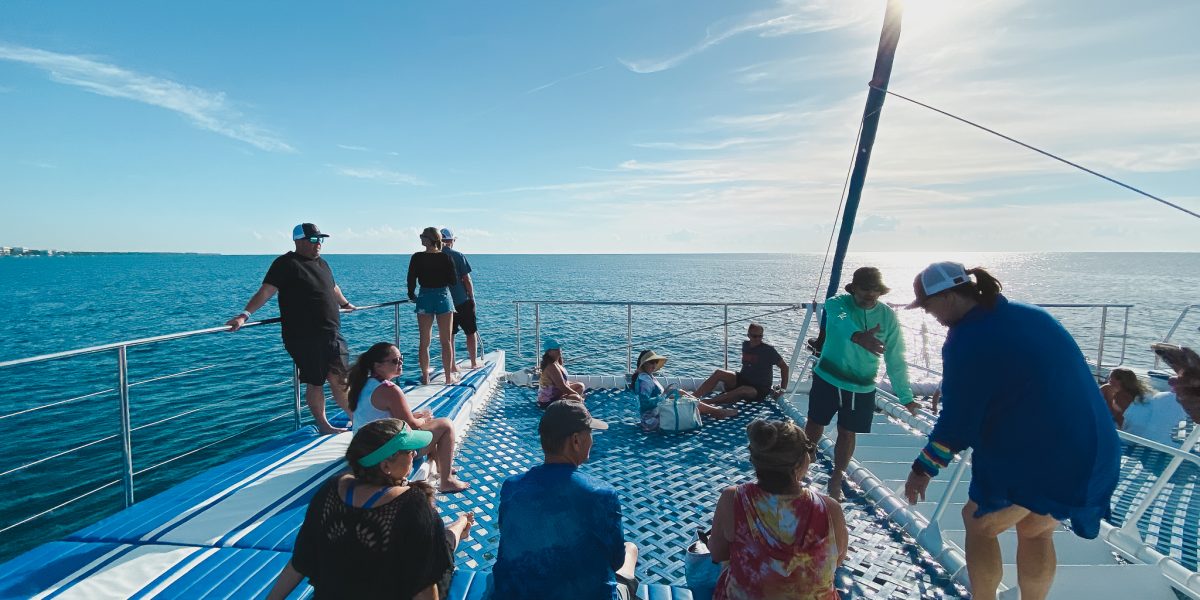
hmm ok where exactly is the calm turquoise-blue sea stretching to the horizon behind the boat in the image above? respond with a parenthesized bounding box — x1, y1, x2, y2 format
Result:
(0, 247, 1200, 559)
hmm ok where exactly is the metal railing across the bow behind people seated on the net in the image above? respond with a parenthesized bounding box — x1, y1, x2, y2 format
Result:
(512, 300, 815, 374)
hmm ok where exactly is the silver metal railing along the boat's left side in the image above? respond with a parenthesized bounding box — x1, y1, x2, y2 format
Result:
(0, 300, 409, 534)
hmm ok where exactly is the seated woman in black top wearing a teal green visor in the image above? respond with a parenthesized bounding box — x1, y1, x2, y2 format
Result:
(268, 419, 475, 600)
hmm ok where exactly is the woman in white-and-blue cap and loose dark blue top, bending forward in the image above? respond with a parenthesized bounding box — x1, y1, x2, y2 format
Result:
(905, 263, 1120, 600)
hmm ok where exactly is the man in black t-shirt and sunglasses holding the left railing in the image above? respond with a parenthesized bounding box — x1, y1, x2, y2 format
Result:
(226, 223, 354, 434)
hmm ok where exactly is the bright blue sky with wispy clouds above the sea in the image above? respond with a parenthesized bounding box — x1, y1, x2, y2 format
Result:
(0, 0, 1200, 254)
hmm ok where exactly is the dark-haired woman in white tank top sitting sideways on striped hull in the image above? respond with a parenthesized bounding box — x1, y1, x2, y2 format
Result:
(347, 342, 470, 493)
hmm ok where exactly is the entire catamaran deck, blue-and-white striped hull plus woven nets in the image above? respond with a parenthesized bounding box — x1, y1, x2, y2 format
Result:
(0, 343, 1200, 600)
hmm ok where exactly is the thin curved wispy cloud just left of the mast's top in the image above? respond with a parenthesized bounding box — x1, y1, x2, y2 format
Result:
(619, 0, 874, 73)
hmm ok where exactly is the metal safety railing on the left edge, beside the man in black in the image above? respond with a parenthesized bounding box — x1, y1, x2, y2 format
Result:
(0, 300, 409, 520)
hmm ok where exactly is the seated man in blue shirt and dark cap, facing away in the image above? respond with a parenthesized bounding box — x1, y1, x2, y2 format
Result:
(490, 400, 637, 600)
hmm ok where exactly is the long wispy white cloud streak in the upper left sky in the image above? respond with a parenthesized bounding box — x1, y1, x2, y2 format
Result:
(0, 44, 295, 152)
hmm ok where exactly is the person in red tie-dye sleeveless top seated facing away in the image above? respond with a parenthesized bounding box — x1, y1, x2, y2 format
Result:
(708, 420, 850, 600)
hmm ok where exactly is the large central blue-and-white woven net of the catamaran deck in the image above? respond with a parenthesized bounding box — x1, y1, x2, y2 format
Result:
(439, 385, 966, 599)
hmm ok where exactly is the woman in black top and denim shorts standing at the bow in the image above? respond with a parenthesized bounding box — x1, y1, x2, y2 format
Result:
(408, 227, 458, 385)
